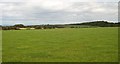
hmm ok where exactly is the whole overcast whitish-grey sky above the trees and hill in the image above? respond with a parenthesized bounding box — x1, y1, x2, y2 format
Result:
(0, 0, 119, 25)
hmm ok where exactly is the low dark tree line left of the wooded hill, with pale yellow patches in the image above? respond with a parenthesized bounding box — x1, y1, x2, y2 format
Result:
(2, 24, 64, 30)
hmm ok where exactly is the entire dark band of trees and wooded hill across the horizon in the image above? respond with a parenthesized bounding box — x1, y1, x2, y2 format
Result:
(0, 21, 120, 30)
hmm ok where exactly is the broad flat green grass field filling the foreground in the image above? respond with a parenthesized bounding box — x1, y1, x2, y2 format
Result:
(2, 28, 118, 62)
